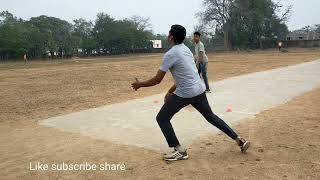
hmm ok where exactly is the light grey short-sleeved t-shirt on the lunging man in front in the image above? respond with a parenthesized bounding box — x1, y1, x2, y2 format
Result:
(160, 44, 206, 98)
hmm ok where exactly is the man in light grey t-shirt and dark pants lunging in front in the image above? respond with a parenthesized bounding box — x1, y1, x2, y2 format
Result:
(131, 25, 250, 161)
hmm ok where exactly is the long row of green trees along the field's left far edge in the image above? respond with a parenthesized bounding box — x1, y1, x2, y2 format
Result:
(0, 11, 154, 60)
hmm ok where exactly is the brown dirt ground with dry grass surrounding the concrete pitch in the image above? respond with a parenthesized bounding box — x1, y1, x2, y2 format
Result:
(0, 50, 320, 179)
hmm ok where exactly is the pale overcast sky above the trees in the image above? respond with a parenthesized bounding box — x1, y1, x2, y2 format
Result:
(0, 0, 320, 33)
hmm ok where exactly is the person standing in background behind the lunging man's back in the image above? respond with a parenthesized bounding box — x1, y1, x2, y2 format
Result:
(193, 32, 211, 92)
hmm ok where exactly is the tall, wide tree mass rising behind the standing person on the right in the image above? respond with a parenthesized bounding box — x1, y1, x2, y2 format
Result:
(200, 0, 292, 49)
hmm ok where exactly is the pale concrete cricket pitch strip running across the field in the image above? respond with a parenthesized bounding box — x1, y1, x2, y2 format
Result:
(39, 60, 320, 150)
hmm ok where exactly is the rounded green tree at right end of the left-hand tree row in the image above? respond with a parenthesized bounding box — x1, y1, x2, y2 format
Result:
(93, 13, 150, 54)
